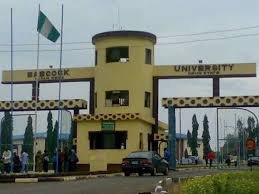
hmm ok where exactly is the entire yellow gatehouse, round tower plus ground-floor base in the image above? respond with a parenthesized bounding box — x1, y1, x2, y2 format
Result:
(75, 31, 167, 171)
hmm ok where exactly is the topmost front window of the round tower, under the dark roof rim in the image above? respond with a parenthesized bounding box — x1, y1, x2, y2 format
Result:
(106, 46, 129, 63)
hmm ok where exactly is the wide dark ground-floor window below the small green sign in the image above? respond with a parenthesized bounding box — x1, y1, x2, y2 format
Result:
(89, 131, 127, 150)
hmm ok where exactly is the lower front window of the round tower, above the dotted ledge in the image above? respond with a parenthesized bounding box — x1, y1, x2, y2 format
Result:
(105, 90, 129, 106)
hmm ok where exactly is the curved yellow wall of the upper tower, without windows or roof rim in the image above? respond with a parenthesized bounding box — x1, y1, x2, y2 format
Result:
(95, 37, 154, 117)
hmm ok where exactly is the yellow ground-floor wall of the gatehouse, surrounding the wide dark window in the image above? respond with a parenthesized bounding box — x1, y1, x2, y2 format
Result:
(77, 120, 151, 171)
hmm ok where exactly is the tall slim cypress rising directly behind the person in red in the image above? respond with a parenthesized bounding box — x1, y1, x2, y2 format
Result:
(202, 115, 211, 156)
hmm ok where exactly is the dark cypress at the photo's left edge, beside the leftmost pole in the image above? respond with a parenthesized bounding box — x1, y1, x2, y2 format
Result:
(1, 111, 13, 151)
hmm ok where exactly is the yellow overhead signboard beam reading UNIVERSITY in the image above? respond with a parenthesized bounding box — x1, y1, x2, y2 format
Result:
(154, 63, 256, 78)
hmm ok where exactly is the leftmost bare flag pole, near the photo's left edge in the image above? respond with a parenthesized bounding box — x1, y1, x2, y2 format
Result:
(10, 8, 13, 172)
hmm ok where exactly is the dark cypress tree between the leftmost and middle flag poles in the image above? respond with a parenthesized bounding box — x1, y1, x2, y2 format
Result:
(22, 116, 34, 161)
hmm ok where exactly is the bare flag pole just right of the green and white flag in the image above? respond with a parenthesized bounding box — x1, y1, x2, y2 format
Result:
(56, 4, 64, 173)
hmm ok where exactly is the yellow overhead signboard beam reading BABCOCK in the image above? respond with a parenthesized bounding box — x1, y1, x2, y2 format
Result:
(2, 67, 94, 84)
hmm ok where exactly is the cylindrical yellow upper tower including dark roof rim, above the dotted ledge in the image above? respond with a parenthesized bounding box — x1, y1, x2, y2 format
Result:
(92, 31, 156, 117)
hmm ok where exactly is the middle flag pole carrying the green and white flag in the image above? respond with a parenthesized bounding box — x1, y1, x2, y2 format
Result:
(33, 4, 40, 172)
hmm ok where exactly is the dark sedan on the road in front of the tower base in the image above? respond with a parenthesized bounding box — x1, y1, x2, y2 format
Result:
(122, 151, 169, 176)
